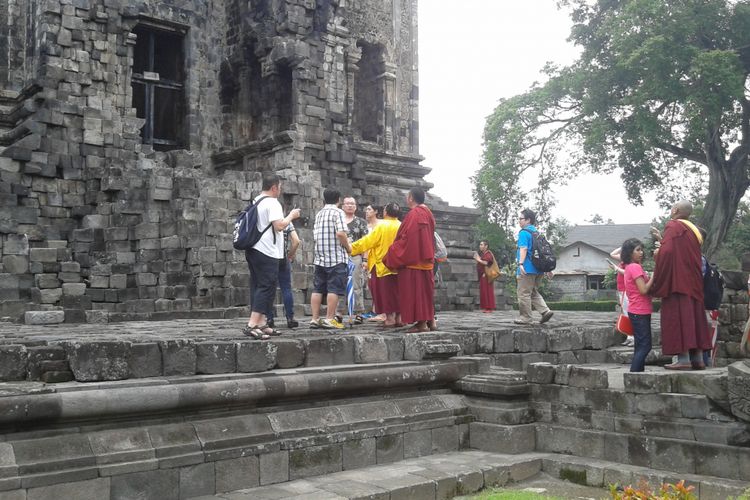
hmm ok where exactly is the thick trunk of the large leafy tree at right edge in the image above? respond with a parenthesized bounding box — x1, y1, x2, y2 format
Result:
(700, 155, 750, 260)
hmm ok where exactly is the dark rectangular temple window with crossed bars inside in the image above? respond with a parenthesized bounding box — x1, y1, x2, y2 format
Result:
(132, 25, 186, 151)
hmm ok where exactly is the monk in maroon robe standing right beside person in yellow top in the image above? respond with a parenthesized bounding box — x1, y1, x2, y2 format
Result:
(383, 188, 435, 332)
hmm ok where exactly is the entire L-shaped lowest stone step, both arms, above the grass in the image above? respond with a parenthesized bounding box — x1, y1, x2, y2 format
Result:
(191, 450, 750, 500)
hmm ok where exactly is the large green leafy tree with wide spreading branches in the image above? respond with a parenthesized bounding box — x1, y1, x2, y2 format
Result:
(474, 0, 750, 255)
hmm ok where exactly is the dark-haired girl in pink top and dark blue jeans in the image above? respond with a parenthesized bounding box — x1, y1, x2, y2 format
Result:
(620, 238, 653, 372)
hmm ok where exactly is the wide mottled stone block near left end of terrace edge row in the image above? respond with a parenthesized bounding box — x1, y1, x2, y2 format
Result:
(62, 341, 130, 382)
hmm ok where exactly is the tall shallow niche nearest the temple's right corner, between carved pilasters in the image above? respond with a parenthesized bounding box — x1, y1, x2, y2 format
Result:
(354, 42, 385, 142)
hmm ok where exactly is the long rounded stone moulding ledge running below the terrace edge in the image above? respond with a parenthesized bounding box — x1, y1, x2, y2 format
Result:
(0, 358, 486, 426)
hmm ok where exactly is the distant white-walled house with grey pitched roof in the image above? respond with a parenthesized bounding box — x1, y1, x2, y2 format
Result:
(550, 224, 651, 300)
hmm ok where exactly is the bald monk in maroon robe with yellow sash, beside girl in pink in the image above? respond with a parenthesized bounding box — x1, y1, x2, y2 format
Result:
(650, 200, 711, 370)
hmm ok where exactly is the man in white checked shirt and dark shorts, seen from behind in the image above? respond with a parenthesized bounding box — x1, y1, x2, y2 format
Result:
(310, 187, 351, 330)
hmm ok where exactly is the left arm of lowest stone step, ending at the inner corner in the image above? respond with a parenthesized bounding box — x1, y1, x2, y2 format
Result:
(188, 450, 546, 500)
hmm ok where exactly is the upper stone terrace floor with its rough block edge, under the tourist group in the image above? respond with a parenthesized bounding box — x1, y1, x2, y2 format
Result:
(0, 311, 658, 383)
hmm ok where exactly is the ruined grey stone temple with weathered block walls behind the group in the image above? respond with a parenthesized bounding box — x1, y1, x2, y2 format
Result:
(0, 0, 482, 322)
